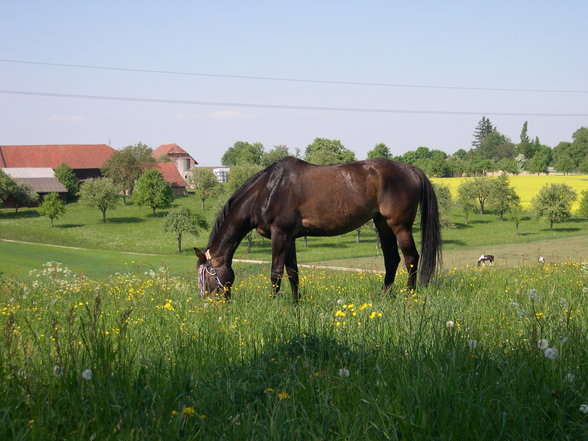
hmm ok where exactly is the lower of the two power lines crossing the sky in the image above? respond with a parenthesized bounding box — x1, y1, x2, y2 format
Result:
(0, 89, 588, 117)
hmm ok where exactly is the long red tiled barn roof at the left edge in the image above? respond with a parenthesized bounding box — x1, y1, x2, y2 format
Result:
(0, 144, 116, 169)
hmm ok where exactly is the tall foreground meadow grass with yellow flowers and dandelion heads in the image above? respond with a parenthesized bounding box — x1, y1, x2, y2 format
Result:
(0, 262, 588, 440)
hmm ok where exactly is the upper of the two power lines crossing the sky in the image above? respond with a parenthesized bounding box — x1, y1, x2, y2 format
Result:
(0, 59, 588, 93)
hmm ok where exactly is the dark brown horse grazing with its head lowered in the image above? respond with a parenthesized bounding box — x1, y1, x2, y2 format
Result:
(194, 157, 441, 301)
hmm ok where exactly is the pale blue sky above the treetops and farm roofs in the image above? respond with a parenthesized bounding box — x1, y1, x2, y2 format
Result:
(0, 0, 588, 166)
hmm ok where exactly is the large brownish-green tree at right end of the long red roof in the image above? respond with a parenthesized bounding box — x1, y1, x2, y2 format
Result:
(101, 142, 156, 204)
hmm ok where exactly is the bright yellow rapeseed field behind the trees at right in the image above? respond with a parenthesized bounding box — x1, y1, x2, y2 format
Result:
(432, 175, 588, 210)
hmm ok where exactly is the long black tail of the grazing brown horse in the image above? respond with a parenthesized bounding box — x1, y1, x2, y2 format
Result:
(419, 173, 441, 285)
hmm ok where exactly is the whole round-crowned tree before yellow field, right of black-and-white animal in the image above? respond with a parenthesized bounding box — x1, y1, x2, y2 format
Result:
(531, 184, 577, 230)
